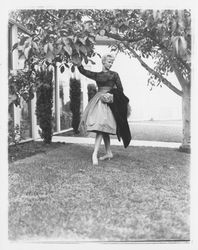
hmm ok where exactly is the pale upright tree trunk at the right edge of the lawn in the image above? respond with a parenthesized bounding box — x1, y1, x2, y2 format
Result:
(180, 86, 191, 153)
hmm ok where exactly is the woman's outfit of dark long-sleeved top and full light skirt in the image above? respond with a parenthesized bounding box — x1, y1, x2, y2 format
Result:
(78, 66, 123, 134)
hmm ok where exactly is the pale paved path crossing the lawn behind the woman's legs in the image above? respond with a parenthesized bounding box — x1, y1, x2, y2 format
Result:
(52, 136, 181, 148)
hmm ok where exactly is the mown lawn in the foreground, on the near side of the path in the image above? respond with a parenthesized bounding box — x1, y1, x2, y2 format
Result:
(9, 143, 190, 241)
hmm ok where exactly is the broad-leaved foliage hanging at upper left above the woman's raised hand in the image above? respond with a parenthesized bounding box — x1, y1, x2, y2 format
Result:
(10, 9, 95, 71)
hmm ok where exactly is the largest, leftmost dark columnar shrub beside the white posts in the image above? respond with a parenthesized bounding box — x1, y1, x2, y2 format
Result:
(36, 71, 53, 143)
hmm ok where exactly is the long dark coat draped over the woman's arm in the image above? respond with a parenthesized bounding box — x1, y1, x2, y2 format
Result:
(108, 88, 131, 148)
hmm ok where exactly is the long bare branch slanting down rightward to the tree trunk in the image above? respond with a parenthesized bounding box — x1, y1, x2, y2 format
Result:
(125, 44, 182, 96)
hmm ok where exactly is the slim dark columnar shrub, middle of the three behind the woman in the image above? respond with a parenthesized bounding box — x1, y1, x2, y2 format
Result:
(70, 78, 81, 134)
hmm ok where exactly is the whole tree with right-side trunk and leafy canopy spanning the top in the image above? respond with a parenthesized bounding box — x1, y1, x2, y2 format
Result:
(11, 9, 191, 150)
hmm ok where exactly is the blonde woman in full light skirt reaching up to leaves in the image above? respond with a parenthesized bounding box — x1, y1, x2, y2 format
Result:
(74, 54, 123, 165)
